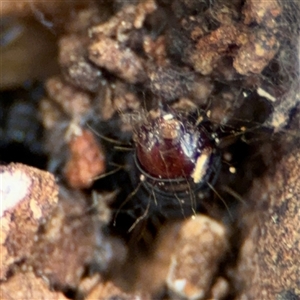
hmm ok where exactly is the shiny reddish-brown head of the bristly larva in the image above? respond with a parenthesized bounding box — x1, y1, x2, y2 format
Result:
(134, 113, 216, 190)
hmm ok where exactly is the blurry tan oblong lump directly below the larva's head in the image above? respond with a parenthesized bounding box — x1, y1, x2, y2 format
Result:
(167, 215, 228, 299)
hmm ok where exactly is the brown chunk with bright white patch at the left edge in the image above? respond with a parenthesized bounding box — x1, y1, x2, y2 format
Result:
(0, 164, 58, 279)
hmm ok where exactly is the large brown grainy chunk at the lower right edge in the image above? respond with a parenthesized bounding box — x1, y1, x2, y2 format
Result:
(238, 150, 300, 300)
